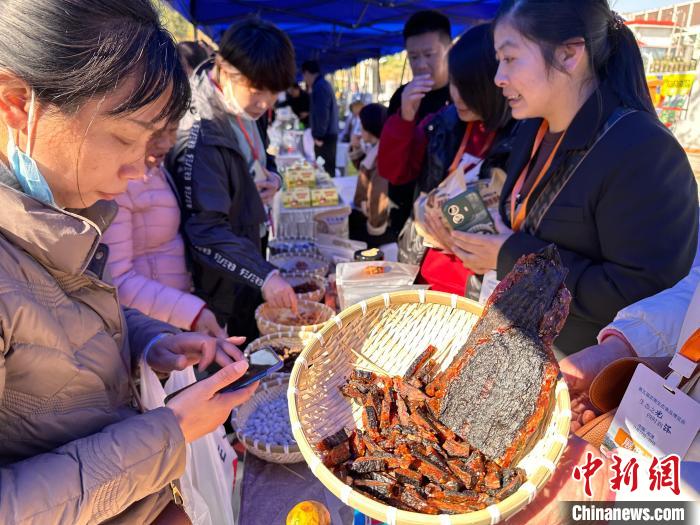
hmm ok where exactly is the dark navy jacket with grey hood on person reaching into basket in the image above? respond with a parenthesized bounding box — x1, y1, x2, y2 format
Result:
(167, 61, 275, 320)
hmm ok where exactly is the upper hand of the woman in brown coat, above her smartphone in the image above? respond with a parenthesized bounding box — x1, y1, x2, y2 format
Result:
(146, 332, 245, 374)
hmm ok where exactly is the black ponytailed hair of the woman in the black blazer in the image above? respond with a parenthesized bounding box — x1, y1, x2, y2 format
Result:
(494, 0, 656, 115)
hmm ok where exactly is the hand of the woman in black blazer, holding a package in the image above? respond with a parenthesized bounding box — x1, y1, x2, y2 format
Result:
(452, 213, 513, 275)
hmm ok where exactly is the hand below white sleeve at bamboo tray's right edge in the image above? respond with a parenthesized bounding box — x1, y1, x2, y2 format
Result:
(559, 334, 636, 397)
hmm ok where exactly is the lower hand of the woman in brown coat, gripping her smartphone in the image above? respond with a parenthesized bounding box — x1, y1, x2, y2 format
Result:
(167, 360, 258, 443)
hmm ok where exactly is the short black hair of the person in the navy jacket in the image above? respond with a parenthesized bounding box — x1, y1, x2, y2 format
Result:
(219, 18, 296, 92)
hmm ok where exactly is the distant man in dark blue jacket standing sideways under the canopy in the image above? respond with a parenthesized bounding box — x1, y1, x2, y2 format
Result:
(301, 60, 338, 177)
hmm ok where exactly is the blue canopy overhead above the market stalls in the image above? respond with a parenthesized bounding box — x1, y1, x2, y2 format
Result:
(167, 0, 500, 71)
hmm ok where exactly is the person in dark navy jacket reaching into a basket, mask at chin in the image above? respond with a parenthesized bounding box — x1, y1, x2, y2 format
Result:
(168, 20, 296, 340)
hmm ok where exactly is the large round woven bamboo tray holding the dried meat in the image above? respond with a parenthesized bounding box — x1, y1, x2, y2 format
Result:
(287, 290, 571, 525)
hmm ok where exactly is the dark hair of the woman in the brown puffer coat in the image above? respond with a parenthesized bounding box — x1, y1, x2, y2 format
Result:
(0, 0, 190, 120)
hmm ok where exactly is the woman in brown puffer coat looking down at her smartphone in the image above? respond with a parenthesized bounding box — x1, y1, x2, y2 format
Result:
(0, 0, 255, 524)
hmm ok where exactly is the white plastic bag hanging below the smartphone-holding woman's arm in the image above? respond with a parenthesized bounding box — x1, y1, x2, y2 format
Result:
(140, 360, 236, 525)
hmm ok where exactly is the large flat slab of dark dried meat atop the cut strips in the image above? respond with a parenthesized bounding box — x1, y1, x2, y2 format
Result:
(427, 247, 570, 467)
